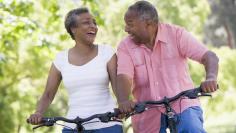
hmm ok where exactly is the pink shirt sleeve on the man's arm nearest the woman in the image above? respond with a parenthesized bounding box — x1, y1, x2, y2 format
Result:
(117, 41, 134, 78)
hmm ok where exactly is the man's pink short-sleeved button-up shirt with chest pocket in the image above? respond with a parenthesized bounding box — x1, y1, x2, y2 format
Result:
(117, 23, 207, 133)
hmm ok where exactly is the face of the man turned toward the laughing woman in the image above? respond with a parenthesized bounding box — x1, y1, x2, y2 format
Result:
(124, 10, 148, 45)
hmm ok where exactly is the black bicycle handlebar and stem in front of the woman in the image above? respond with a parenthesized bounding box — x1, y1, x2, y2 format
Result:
(27, 109, 122, 133)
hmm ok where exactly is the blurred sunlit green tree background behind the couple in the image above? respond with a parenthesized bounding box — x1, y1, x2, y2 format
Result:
(0, 0, 236, 133)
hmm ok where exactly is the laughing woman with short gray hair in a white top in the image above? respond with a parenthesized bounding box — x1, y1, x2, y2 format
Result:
(28, 8, 122, 133)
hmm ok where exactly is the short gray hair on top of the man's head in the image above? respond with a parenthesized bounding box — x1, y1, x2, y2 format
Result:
(128, 1, 158, 23)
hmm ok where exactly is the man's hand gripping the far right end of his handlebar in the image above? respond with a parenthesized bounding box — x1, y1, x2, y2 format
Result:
(201, 78, 218, 93)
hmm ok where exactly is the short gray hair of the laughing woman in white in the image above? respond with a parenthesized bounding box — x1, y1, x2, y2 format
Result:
(64, 7, 89, 40)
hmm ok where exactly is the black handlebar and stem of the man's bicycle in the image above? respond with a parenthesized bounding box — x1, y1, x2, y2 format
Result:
(126, 87, 211, 133)
